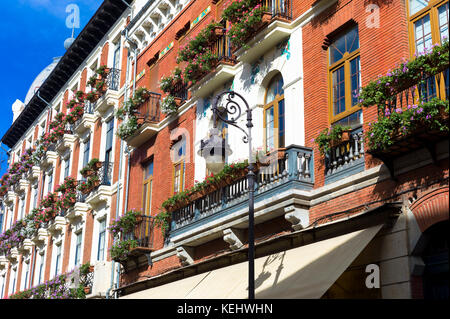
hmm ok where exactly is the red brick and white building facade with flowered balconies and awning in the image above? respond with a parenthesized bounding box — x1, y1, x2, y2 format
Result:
(0, 0, 449, 298)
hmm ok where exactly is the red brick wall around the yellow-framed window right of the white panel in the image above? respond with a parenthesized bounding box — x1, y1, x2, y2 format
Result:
(303, 0, 409, 188)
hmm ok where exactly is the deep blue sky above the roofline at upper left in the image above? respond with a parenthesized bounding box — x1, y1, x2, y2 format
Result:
(0, 0, 103, 176)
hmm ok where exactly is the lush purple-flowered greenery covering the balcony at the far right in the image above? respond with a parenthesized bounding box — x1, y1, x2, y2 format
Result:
(359, 41, 449, 155)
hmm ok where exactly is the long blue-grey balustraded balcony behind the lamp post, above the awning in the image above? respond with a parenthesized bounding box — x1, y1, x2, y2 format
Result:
(170, 145, 314, 246)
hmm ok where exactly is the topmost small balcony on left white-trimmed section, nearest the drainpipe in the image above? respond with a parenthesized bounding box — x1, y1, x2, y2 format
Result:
(94, 68, 120, 116)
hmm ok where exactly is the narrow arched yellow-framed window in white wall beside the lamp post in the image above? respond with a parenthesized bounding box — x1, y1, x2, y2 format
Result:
(264, 74, 285, 152)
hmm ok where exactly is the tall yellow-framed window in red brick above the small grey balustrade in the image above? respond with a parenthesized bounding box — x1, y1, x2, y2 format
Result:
(328, 26, 361, 123)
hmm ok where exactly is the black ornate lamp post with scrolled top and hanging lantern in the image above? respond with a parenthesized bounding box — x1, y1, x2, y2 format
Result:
(202, 91, 255, 300)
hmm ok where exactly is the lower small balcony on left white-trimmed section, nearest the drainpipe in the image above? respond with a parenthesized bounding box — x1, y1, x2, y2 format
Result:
(85, 162, 114, 207)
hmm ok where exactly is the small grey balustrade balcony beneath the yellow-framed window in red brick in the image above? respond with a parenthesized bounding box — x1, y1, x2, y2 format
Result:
(325, 126, 364, 184)
